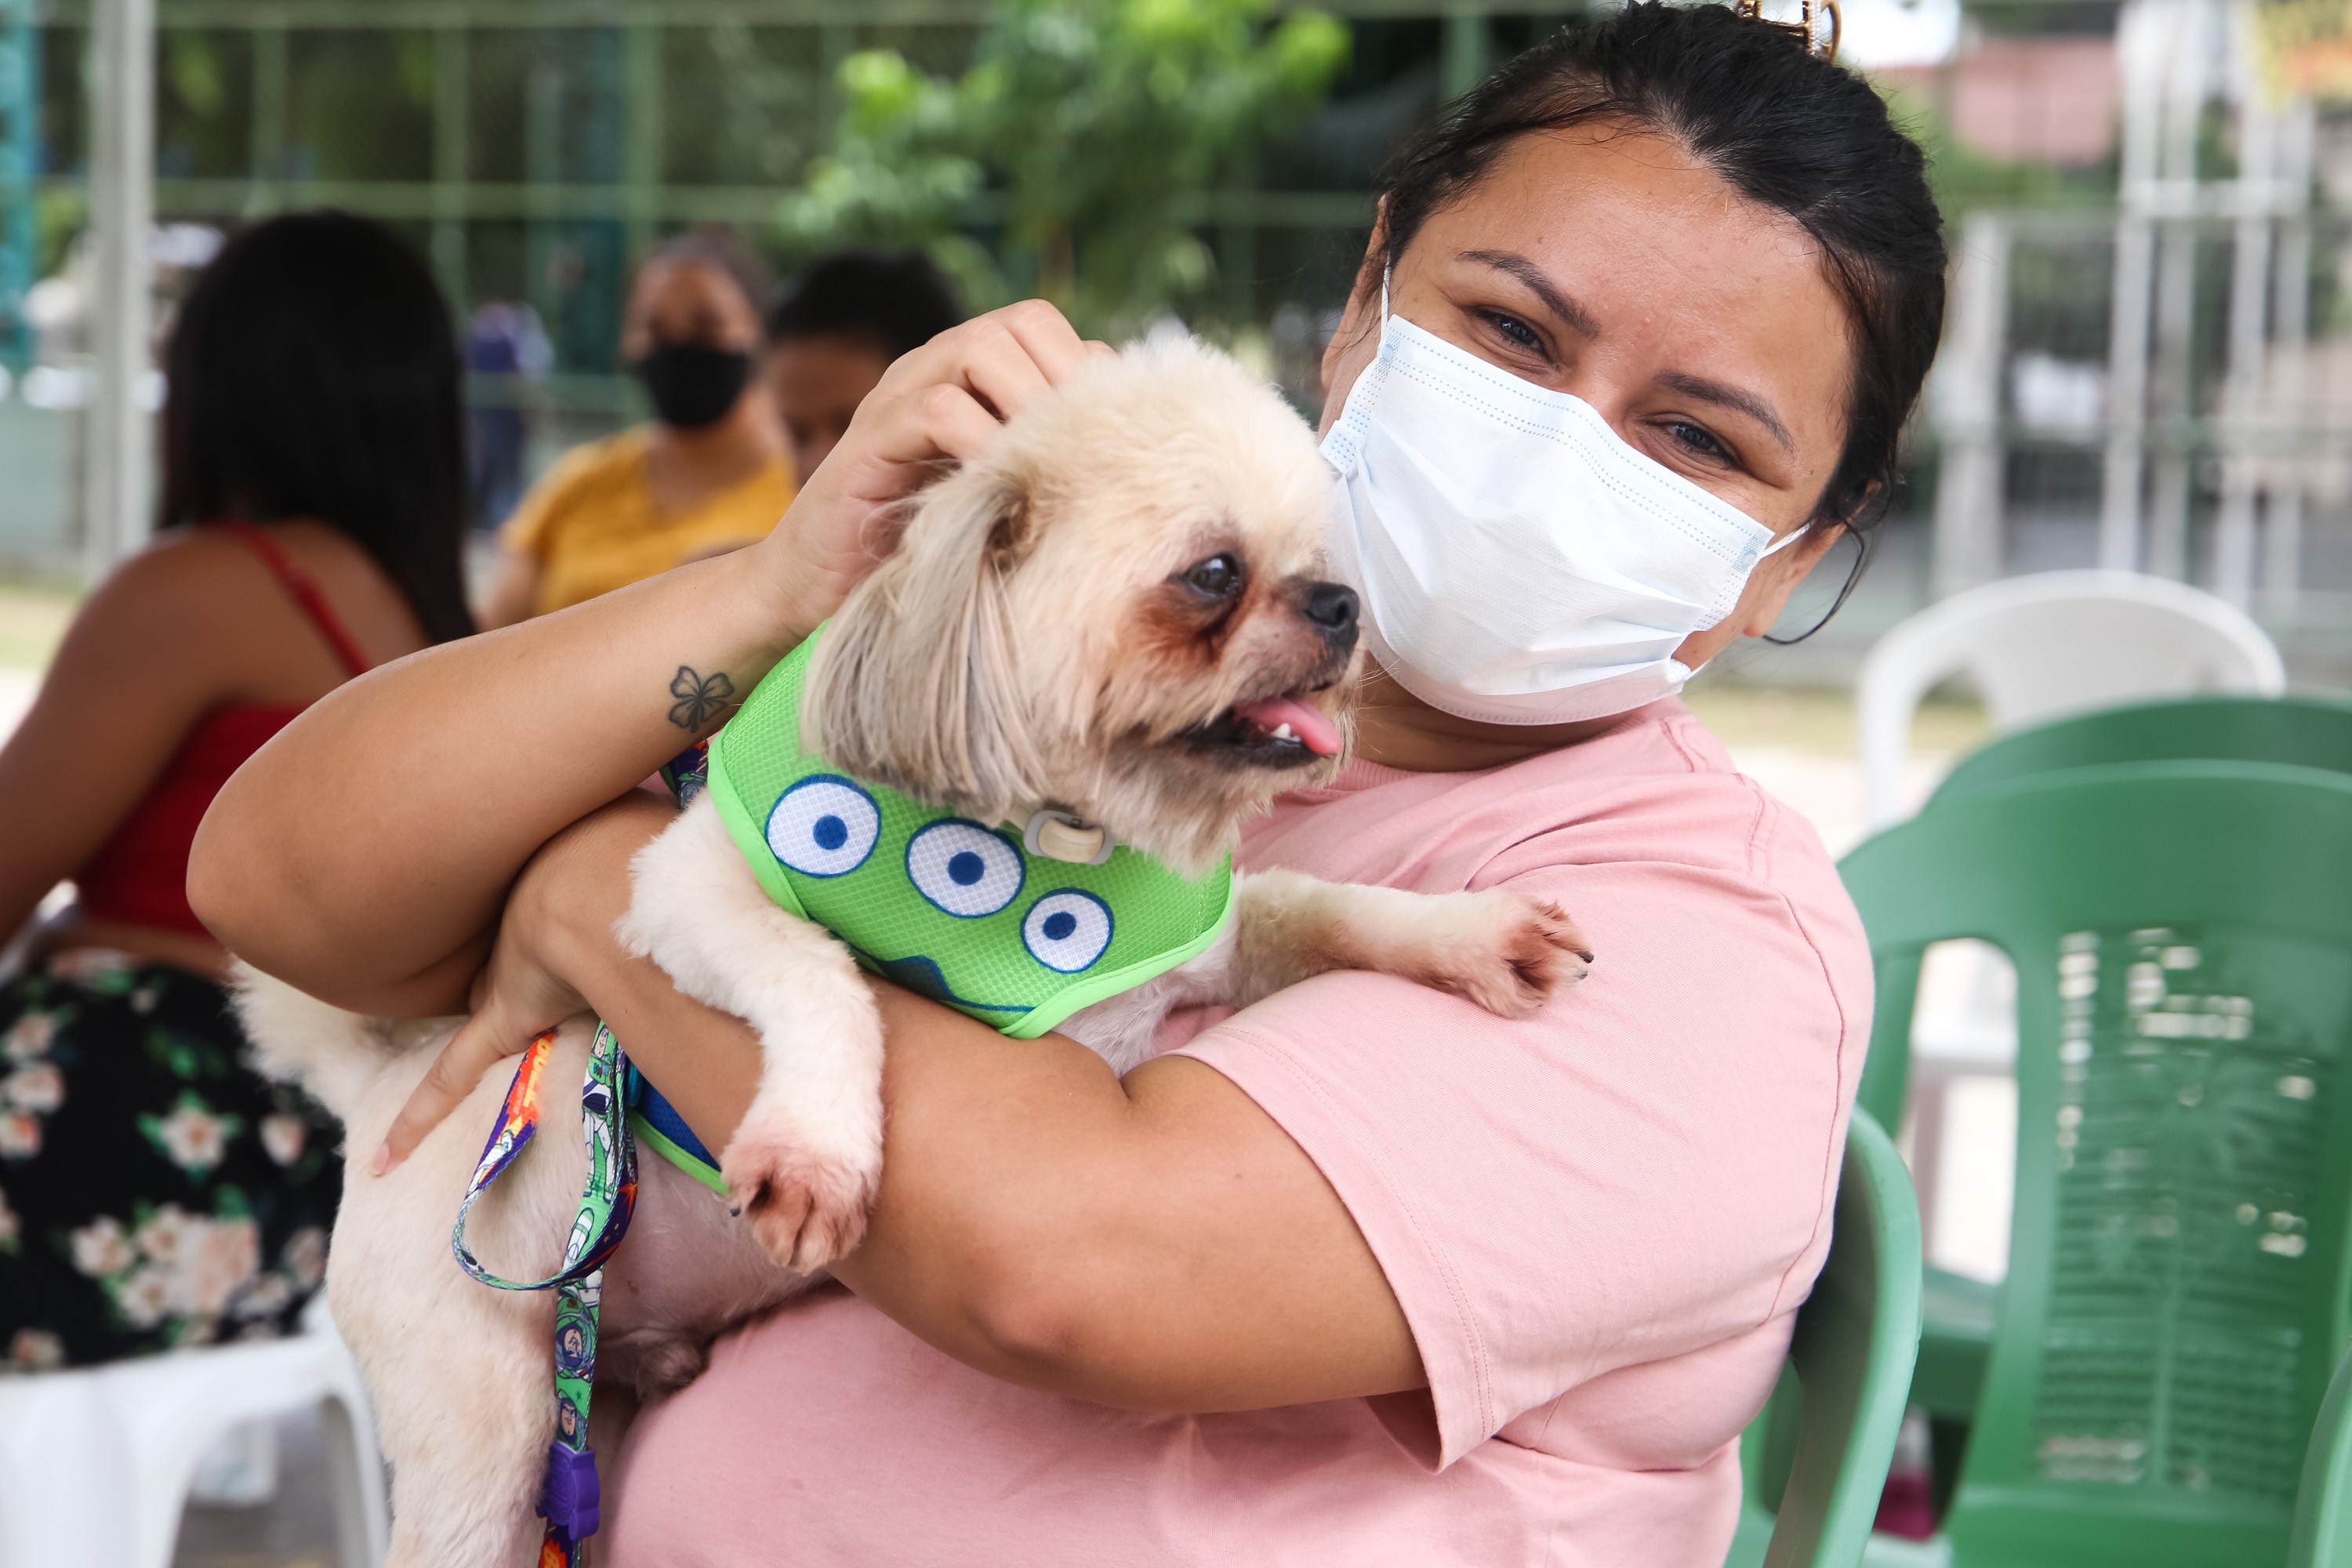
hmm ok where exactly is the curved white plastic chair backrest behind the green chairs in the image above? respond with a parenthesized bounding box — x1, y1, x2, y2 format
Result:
(1853, 572, 2286, 827)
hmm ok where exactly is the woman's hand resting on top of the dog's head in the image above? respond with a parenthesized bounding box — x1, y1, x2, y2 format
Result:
(748, 299, 1110, 635)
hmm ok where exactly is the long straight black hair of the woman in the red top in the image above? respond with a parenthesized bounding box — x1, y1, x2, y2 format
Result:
(158, 212, 473, 642)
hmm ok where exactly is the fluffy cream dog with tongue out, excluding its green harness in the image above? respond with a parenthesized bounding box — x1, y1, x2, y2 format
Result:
(242, 346, 1588, 1568)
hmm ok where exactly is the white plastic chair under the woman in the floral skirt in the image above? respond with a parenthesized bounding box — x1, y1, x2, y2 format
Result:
(0, 1314, 386, 1568)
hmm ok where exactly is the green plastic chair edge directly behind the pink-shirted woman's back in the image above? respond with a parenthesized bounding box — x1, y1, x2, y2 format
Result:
(1724, 1112, 1919, 1568)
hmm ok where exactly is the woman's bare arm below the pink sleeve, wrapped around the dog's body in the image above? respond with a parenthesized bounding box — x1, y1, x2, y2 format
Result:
(515, 797, 1423, 1410)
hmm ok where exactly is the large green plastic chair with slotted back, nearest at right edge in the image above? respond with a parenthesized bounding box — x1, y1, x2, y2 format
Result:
(1842, 762, 2352, 1568)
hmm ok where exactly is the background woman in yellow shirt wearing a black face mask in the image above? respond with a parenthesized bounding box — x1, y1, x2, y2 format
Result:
(480, 235, 793, 628)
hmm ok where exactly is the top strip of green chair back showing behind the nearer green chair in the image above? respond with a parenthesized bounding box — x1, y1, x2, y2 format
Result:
(1924, 696, 2352, 811)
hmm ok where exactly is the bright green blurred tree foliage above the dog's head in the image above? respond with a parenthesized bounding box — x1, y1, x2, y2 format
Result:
(779, 0, 1348, 334)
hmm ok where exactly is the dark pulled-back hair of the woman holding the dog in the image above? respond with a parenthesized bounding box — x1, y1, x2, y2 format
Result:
(1378, 0, 1945, 540)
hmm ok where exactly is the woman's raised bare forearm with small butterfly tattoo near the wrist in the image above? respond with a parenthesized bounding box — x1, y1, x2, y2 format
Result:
(188, 550, 821, 1013)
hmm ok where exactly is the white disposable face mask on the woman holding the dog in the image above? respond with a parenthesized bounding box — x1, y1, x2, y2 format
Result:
(1322, 287, 1804, 724)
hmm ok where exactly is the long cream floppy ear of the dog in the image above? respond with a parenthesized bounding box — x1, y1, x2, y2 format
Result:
(800, 463, 1040, 822)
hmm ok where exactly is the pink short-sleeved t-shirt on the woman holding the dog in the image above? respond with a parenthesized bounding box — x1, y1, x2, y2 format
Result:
(609, 701, 1870, 1568)
